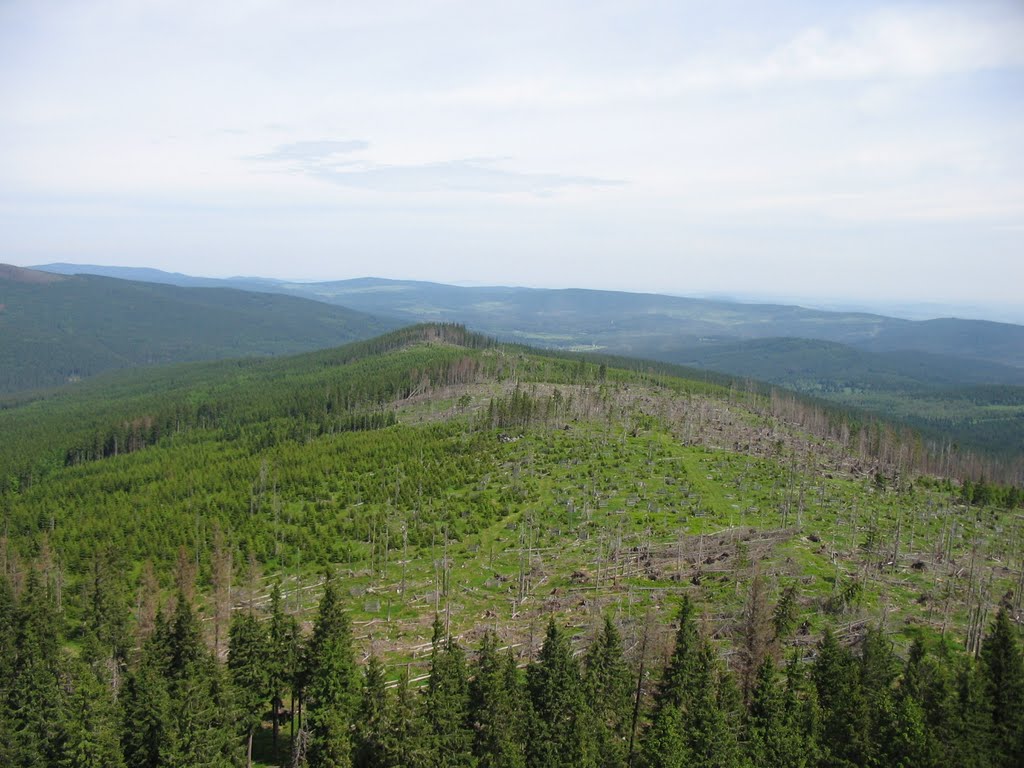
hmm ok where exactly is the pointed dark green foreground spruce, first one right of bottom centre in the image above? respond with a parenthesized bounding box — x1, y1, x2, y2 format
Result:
(526, 618, 596, 768)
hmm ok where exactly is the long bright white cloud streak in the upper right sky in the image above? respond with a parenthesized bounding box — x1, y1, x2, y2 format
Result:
(427, 6, 1024, 111)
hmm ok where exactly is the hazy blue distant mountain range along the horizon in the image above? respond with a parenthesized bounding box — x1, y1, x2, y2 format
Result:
(35, 264, 1024, 368)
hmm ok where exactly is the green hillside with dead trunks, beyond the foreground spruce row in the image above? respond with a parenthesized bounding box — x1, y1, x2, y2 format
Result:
(0, 326, 1021, 653)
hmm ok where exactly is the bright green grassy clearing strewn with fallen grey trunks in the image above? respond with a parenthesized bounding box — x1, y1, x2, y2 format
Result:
(234, 403, 1021, 674)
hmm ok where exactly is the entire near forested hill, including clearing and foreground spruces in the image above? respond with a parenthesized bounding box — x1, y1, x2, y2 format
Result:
(0, 325, 1024, 768)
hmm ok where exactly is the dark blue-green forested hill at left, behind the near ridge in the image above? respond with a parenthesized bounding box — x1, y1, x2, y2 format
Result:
(0, 265, 397, 392)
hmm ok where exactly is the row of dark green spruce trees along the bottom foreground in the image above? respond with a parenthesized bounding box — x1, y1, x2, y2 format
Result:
(0, 552, 1022, 768)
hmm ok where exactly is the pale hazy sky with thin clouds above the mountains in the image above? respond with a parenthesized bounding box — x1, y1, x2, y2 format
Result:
(0, 0, 1024, 304)
